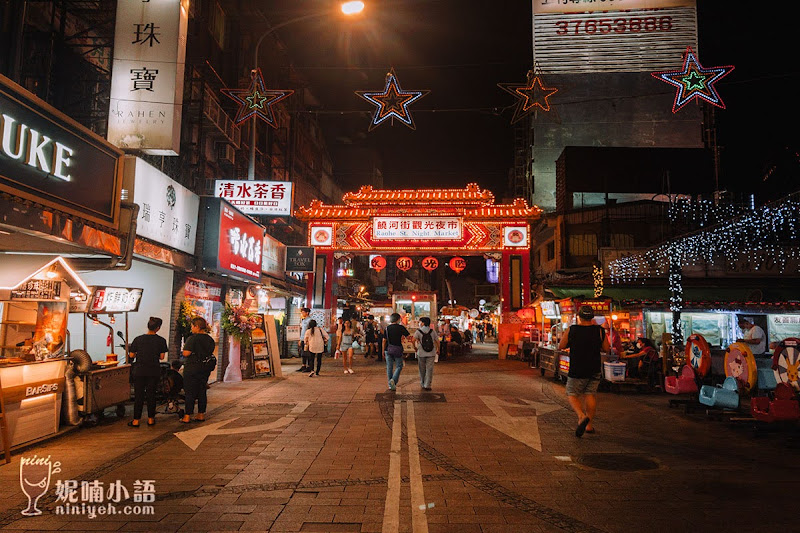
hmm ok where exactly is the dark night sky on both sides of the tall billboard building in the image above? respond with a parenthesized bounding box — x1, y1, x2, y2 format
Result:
(265, 0, 800, 199)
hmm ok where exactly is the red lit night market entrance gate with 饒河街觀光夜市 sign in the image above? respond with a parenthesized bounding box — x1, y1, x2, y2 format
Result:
(296, 183, 541, 338)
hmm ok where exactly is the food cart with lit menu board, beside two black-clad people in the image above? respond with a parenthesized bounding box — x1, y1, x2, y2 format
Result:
(66, 287, 142, 425)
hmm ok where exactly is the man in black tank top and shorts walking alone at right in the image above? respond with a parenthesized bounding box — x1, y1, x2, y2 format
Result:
(558, 305, 611, 437)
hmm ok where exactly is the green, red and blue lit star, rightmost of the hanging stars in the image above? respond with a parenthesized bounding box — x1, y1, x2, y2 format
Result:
(652, 46, 734, 113)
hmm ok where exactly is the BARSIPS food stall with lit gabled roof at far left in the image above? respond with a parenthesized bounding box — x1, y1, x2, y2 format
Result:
(0, 254, 90, 447)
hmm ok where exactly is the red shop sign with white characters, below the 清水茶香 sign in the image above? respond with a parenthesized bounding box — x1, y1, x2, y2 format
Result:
(201, 197, 265, 281)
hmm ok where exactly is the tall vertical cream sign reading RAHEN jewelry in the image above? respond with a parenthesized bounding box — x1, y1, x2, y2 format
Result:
(108, 0, 189, 156)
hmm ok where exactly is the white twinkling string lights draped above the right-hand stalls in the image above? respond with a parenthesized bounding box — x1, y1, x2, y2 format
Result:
(608, 193, 800, 283)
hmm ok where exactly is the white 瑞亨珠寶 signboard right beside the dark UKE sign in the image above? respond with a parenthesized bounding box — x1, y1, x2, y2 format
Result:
(130, 156, 200, 254)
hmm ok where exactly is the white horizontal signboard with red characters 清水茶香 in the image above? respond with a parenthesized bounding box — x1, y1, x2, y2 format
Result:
(214, 180, 292, 216)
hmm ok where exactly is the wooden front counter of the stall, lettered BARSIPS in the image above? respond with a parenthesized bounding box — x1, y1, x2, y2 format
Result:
(0, 359, 67, 447)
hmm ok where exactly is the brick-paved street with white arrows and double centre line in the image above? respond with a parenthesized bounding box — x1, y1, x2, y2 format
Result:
(0, 345, 800, 533)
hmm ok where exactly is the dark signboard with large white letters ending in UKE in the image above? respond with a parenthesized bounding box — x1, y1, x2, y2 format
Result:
(0, 75, 122, 228)
